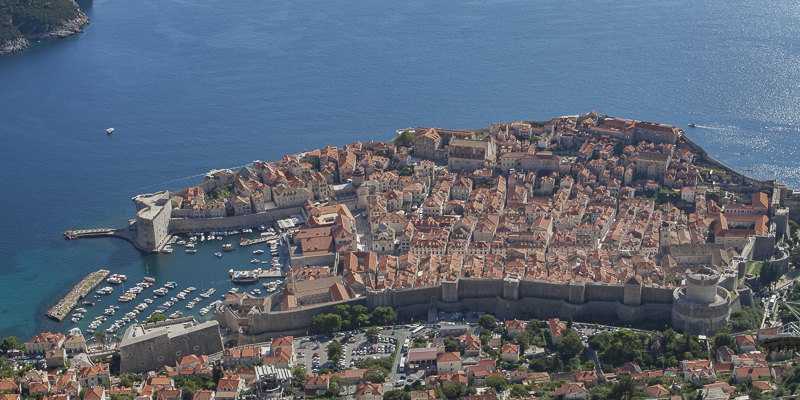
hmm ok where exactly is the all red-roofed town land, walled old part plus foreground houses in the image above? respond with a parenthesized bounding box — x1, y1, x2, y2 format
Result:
(32, 111, 800, 400)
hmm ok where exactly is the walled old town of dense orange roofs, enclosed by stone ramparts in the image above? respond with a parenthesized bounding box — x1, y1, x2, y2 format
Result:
(65, 111, 800, 340)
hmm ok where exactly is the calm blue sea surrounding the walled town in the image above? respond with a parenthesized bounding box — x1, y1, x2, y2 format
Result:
(0, 0, 800, 340)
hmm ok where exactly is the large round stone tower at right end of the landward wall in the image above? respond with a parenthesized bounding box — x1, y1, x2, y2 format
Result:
(672, 268, 731, 335)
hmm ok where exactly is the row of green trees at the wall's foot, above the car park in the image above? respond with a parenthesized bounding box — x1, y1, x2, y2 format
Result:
(311, 304, 397, 333)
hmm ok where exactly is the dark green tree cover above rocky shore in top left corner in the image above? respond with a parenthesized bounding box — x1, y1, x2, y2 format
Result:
(0, 0, 78, 42)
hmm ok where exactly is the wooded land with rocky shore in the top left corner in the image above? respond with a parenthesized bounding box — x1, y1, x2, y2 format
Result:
(0, 0, 89, 55)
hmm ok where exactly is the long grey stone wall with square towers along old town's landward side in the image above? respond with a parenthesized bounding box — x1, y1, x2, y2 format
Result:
(215, 278, 743, 345)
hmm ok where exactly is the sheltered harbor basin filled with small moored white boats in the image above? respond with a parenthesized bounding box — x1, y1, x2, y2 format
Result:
(47, 224, 288, 334)
